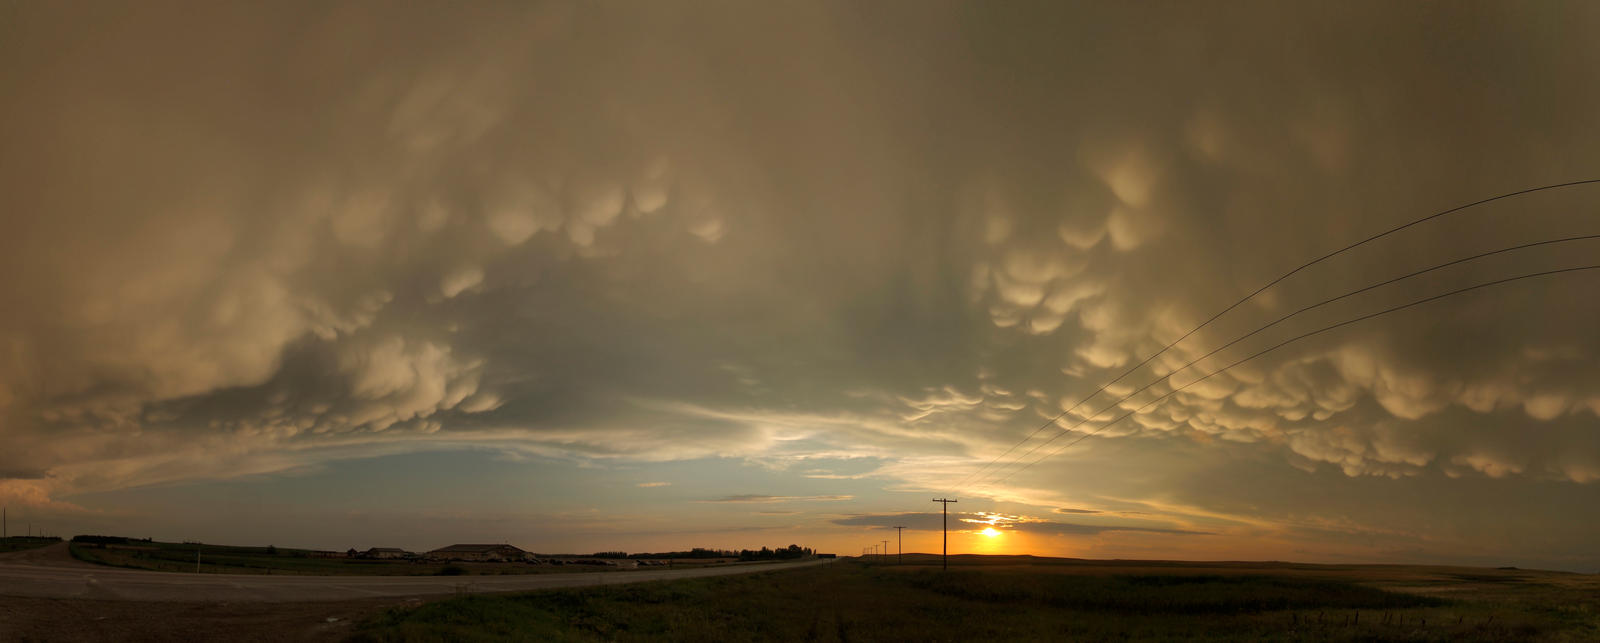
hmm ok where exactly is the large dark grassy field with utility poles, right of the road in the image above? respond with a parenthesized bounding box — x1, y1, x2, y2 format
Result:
(355, 557, 1600, 641)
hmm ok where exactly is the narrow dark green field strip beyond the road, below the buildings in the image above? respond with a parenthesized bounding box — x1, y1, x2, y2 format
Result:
(64, 541, 726, 576)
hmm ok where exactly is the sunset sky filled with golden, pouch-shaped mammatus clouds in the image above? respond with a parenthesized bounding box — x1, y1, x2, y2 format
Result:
(0, 0, 1600, 571)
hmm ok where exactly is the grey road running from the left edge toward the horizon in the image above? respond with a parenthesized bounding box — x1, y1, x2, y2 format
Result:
(0, 544, 826, 601)
